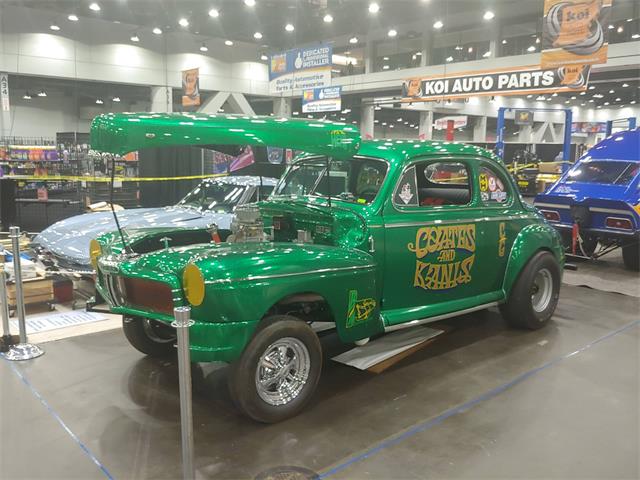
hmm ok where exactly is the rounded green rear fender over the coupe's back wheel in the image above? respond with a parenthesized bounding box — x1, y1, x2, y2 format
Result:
(502, 223, 564, 298)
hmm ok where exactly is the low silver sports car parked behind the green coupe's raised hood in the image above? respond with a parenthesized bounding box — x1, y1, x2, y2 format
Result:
(33, 176, 277, 273)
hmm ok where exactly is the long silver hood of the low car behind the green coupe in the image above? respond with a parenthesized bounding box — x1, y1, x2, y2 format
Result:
(33, 206, 233, 268)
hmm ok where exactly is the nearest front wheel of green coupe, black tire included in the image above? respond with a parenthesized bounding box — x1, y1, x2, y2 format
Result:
(229, 315, 322, 423)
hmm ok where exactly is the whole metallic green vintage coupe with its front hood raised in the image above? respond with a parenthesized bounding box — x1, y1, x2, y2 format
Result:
(91, 114, 564, 422)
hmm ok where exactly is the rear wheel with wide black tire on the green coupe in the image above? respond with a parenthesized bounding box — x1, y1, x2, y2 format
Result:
(500, 251, 561, 330)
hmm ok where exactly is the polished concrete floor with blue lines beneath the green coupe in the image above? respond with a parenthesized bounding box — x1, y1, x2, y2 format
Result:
(0, 286, 640, 479)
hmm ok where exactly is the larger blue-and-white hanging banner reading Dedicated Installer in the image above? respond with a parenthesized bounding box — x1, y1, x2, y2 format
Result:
(269, 44, 333, 94)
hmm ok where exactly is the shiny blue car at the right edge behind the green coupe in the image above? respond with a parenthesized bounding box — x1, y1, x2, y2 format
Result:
(534, 129, 640, 271)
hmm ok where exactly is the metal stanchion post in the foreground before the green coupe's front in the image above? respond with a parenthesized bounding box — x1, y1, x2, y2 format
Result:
(171, 307, 195, 480)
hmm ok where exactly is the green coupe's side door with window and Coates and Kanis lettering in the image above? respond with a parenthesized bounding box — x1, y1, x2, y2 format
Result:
(382, 158, 482, 325)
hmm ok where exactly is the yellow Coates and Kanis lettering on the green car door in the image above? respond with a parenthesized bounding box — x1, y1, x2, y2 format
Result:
(407, 224, 476, 290)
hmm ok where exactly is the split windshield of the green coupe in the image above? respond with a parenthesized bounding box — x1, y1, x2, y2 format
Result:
(273, 156, 388, 204)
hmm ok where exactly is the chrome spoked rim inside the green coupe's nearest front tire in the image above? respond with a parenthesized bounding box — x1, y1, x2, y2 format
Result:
(256, 337, 311, 405)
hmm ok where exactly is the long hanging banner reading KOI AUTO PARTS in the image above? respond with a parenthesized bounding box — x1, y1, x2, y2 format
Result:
(402, 66, 590, 102)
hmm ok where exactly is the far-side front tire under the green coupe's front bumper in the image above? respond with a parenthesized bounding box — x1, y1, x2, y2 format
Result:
(122, 315, 176, 358)
